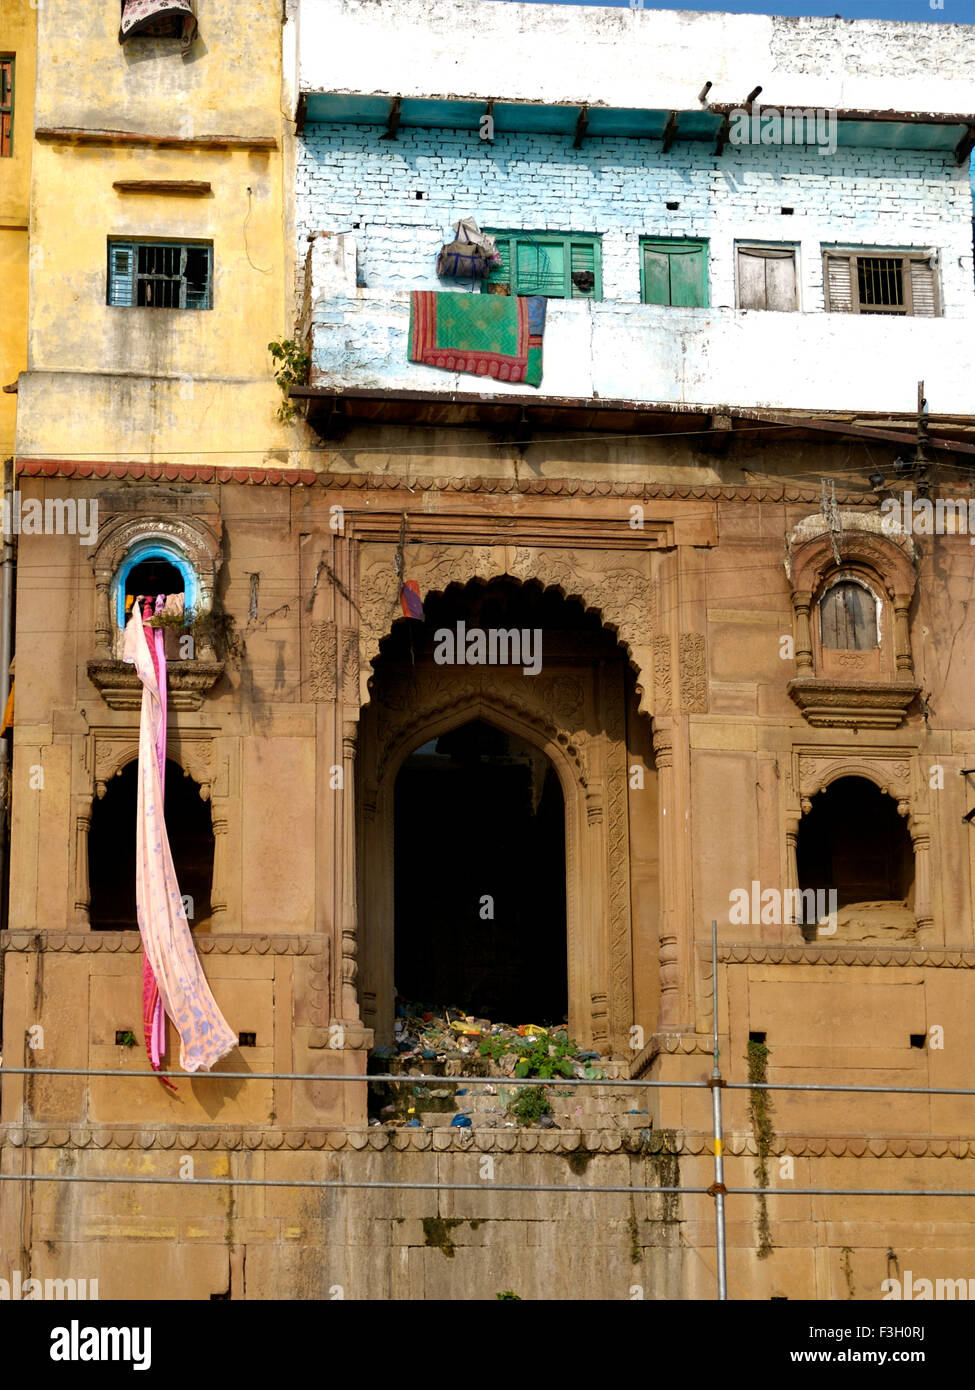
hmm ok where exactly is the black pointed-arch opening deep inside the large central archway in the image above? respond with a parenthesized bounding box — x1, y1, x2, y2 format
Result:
(395, 720, 567, 1023)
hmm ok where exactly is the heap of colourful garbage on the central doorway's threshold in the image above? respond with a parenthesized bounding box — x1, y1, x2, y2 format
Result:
(373, 995, 602, 1081)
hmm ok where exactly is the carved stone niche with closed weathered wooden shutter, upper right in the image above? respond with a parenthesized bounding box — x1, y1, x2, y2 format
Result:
(786, 513, 918, 728)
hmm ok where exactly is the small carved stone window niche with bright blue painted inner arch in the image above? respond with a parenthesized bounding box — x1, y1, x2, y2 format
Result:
(88, 518, 224, 710)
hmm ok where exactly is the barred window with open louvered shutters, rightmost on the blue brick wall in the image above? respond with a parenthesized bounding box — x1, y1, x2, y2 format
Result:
(823, 250, 940, 318)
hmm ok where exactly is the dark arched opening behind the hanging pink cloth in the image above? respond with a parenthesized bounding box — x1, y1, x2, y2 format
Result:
(88, 760, 213, 931)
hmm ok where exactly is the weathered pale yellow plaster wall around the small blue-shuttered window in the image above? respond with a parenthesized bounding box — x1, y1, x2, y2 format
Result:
(17, 0, 299, 466)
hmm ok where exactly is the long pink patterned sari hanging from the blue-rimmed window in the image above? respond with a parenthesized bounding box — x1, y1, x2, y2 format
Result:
(122, 602, 236, 1072)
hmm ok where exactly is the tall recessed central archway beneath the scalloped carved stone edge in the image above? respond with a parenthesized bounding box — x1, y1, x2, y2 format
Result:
(356, 578, 658, 1054)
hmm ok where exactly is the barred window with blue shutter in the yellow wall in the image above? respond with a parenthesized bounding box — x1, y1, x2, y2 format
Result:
(108, 242, 213, 309)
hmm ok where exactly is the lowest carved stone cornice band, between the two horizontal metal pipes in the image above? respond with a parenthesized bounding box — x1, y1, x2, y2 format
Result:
(0, 1123, 975, 1159)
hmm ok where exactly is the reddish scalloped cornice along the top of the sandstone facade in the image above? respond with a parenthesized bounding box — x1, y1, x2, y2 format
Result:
(17, 464, 875, 512)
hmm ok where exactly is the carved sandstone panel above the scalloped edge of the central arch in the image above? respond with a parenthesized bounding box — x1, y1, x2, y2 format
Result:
(351, 542, 654, 713)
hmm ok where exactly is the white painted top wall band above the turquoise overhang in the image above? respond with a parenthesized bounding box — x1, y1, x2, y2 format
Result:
(299, 0, 975, 114)
